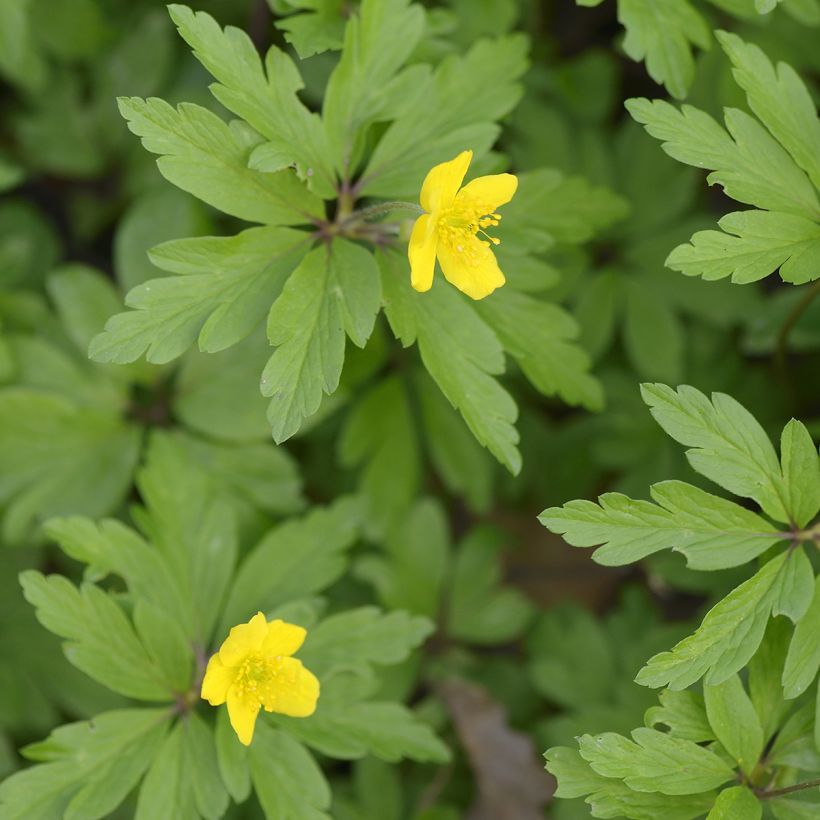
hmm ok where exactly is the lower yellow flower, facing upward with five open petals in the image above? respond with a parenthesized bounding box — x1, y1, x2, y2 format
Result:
(201, 612, 319, 746)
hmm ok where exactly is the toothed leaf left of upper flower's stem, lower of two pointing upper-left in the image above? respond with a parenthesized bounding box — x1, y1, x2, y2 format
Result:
(118, 97, 324, 225)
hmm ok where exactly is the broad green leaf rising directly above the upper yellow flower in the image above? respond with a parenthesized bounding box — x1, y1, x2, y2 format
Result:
(359, 35, 527, 199)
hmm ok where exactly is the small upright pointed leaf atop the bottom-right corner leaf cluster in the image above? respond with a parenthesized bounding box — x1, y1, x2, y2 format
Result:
(703, 675, 764, 776)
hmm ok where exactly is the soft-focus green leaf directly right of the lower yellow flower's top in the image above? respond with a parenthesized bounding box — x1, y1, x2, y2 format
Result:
(299, 606, 434, 677)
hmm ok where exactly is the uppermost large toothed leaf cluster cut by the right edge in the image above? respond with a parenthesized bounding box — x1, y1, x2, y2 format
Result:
(627, 32, 820, 285)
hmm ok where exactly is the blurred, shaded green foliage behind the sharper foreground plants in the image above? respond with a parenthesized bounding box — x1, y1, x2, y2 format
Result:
(0, 0, 820, 820)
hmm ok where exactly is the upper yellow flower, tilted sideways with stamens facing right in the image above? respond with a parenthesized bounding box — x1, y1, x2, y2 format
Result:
(407, 151, 518, 299)
